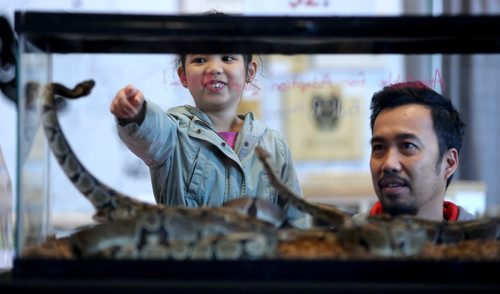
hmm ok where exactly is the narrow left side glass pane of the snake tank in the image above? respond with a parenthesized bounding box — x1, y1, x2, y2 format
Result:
(16, 37, 51, 253)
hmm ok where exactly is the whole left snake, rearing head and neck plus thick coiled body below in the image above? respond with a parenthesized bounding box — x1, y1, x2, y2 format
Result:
(42, 80, 286, 259)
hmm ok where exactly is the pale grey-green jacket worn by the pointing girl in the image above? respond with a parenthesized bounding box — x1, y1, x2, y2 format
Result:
(118, 101, 305, 226)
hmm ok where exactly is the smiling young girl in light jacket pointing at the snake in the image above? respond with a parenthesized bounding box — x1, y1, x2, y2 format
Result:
(110, 54, 305, 227)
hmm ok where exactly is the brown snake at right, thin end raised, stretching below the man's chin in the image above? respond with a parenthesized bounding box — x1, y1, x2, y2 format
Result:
(256, 146, 500, 256)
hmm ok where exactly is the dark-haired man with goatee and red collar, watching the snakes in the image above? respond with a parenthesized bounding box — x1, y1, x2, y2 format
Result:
(354, 82, 474, 222)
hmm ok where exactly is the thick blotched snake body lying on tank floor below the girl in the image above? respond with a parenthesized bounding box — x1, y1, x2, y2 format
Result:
(70, 210, 278, 259)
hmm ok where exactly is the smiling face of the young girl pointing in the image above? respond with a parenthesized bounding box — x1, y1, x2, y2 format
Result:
(177, 54, 257, 112)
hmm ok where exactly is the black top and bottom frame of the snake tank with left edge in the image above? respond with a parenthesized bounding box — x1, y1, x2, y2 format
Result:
(10, 12, 500, 287)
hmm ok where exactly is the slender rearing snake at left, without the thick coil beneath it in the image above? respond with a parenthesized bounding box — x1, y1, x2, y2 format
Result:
(42, 80, 286, 226)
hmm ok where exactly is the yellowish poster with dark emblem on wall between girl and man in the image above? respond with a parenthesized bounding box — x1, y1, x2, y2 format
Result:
(282, 84, 364, 161)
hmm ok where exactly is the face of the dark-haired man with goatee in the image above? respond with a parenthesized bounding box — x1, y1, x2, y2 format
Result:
(370, 104, 449, 215)
